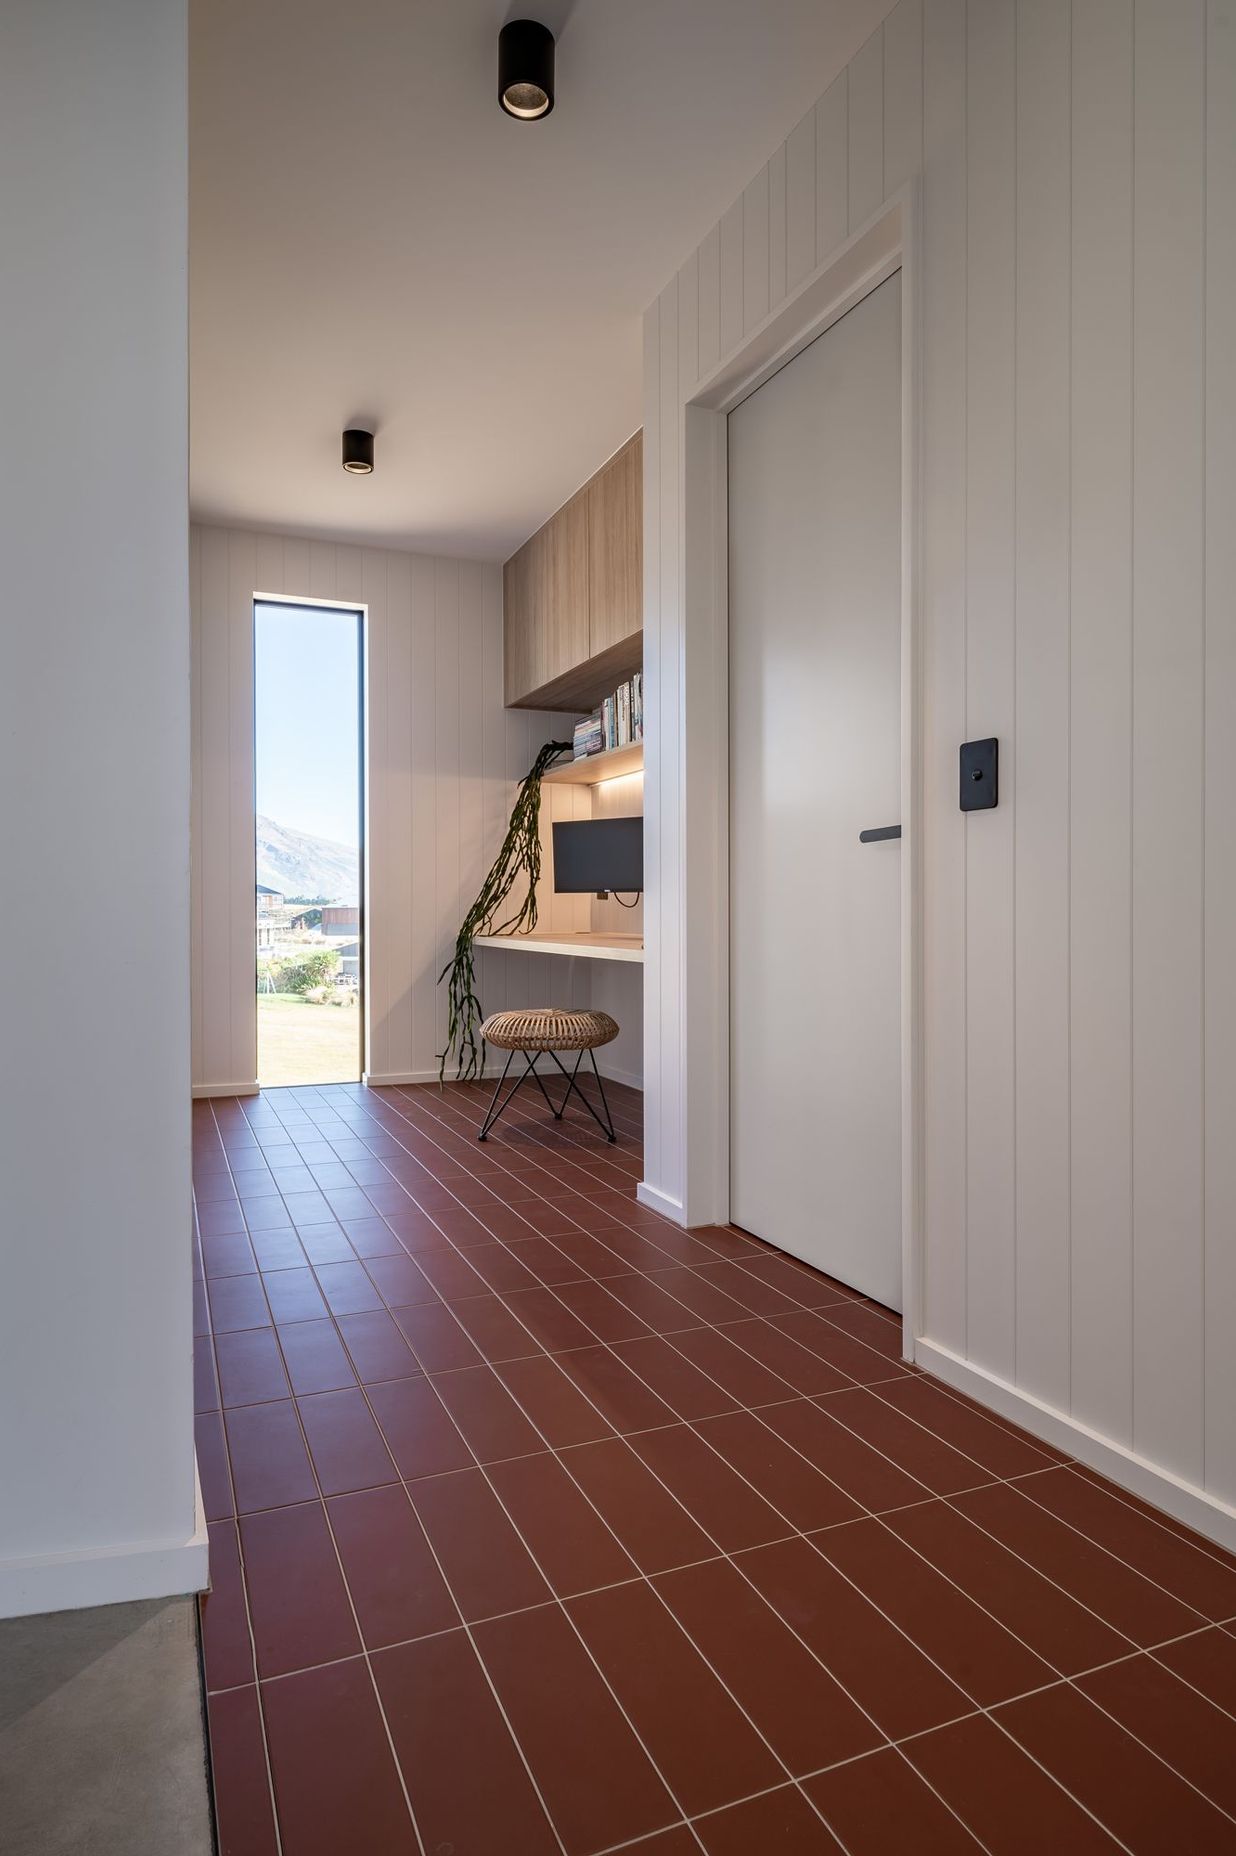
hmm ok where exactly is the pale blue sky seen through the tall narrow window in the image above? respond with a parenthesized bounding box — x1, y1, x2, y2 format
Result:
(254, 603, 360, 844)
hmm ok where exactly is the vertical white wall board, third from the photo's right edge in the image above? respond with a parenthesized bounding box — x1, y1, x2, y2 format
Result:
(1061, 0, 1132, 1444)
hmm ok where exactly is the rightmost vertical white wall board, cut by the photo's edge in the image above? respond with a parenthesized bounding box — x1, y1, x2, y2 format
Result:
(1204, 0, 1236, 1502)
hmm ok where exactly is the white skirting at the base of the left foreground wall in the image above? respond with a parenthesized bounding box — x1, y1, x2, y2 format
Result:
(0, 1470, 210, 1618)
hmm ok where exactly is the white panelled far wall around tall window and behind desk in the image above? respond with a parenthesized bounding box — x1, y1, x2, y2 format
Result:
(191, 523, 640, 1093)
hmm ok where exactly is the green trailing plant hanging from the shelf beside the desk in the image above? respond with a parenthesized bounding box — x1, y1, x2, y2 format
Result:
(438, 741, 572, 1082)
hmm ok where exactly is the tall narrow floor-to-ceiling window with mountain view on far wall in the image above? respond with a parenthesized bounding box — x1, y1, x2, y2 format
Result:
(252, 598, 366, 1088)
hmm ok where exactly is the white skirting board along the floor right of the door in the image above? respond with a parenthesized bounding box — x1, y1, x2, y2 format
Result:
(915, 1340, 1236, 1552)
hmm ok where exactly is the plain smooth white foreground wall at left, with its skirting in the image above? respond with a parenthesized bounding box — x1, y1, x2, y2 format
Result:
(0, 0, 206, 1615)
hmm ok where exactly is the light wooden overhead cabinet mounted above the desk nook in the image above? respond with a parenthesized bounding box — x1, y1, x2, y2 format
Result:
(503, 432, 644, 711)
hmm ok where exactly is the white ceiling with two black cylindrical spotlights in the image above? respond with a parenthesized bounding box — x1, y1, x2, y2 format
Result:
(189, 0, 891, 559)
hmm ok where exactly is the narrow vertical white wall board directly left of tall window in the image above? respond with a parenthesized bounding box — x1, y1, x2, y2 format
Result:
(226, 529, 258, 1080)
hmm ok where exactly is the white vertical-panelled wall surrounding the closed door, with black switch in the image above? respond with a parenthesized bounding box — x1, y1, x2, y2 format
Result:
(644, 0, 1236, 1537)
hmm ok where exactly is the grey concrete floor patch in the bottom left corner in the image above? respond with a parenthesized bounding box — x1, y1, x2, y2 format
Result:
(0, 1598, 213, 1856)
